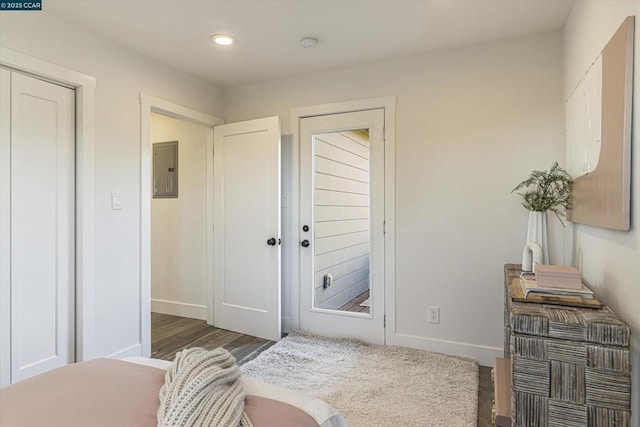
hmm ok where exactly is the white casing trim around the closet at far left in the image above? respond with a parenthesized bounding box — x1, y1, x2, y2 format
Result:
(0, 47, 97, 386)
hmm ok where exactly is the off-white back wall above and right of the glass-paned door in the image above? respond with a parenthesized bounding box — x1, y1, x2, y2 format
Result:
(224, 32, 564, 365)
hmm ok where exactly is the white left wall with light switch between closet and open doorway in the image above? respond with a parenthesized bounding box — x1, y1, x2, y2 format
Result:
(0, 12, 222, 355)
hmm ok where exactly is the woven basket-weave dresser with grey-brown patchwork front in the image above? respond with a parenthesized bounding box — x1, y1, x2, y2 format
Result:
(504, 264, 631, 427)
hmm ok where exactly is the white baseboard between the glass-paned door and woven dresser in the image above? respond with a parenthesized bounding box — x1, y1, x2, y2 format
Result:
(387, 333, 504, 366)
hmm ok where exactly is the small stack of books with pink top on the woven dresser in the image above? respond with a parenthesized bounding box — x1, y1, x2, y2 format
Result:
(520, 265, 593, 299)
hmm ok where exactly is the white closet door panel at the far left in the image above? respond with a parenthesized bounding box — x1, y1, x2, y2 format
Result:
(8, 73, 75, 382)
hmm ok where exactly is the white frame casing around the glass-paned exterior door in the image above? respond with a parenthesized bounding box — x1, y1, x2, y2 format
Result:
(285, 96, 396, 341)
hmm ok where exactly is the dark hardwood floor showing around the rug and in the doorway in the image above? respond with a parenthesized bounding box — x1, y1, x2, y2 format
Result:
(151, 313, 493, 427)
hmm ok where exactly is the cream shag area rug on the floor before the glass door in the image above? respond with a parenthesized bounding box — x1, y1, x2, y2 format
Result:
(241, 331, 478, 427)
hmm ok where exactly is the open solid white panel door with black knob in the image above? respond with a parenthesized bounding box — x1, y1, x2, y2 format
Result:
(213, 117, 281, 341)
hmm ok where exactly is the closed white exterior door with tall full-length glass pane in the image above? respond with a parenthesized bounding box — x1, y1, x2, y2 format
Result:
(299, 109, 385, 344)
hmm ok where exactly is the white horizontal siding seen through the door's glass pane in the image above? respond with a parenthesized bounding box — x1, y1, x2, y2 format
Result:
(316, 132, 371, 309)
